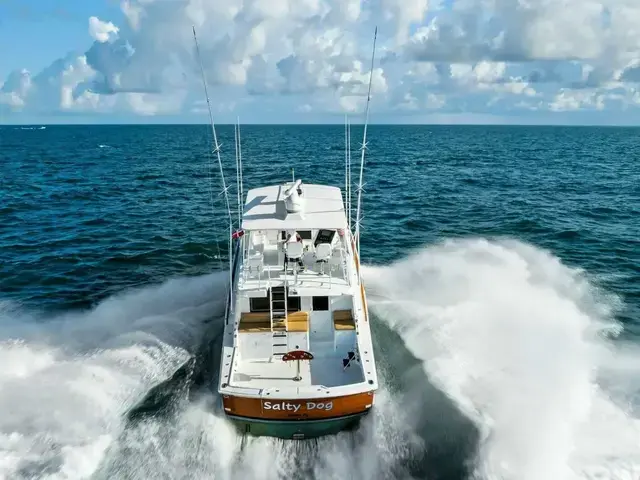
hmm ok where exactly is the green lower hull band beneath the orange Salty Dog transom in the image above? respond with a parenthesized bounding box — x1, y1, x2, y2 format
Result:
(227, 410, 369, 440)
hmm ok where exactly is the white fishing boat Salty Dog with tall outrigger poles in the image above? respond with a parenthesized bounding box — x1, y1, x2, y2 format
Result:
(194, 29, 378, 440)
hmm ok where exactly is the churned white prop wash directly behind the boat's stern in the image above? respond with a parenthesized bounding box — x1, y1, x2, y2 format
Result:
(100, 378, 424, 480)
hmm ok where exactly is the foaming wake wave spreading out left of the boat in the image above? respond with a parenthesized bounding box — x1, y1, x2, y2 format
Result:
(0, 275, 224, 479)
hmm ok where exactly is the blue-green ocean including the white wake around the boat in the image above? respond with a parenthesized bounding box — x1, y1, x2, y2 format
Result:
(0, 125, 640, 480)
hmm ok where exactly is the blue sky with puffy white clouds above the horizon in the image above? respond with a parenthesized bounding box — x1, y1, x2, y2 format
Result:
(0, 0, 640, 125)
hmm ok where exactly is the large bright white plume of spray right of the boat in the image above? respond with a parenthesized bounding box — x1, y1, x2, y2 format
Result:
(365, 240, 640, 480)
